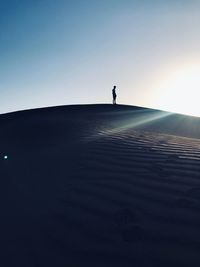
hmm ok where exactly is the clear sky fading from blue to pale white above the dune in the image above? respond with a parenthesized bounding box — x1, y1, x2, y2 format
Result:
(0, 0, 200, 114)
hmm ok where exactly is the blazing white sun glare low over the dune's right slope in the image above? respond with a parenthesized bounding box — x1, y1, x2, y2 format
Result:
(155, 66, 200, 117)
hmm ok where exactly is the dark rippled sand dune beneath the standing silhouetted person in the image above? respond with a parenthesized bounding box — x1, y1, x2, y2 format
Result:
(0, 105, 200, 267)
